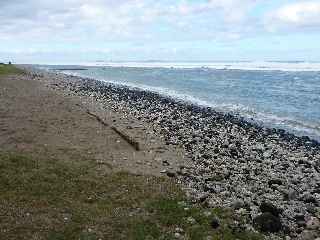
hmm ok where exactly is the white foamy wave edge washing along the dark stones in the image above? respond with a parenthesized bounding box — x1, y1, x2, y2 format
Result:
(35, 64, 320, 142)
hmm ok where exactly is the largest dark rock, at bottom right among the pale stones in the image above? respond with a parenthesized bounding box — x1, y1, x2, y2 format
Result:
(253, 212, 282, 232)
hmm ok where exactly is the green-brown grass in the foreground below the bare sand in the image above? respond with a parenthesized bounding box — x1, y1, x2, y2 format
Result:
(0, 153, 262, 240)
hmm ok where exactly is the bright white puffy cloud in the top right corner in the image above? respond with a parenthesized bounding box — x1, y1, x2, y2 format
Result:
(266, 1, 320, 31)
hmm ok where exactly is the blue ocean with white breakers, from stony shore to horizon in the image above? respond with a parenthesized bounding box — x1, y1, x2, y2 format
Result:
(37, 62, 320, 141)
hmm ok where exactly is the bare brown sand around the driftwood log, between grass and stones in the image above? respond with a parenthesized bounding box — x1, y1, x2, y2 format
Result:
(0, 75, 188, 175)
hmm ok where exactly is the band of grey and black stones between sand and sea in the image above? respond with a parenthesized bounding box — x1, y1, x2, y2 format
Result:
(21, 66, 320, 240)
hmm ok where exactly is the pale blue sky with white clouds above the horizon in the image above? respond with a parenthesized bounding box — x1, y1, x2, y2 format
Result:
(0, 0, 320, 63)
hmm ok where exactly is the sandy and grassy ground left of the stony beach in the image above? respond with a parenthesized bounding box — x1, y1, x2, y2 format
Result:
(0, 66, 250, 240)
